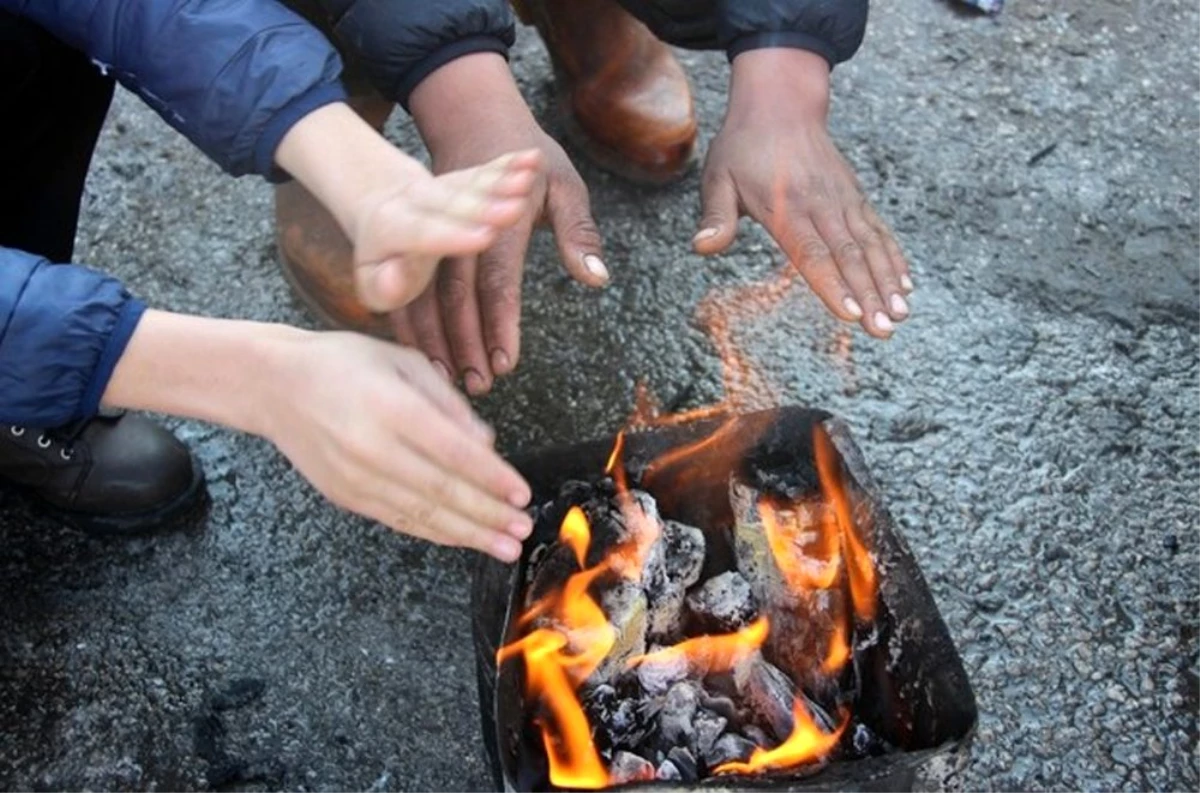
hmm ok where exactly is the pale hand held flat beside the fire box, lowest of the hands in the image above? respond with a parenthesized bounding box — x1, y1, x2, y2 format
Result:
(260, 332, 533, 561)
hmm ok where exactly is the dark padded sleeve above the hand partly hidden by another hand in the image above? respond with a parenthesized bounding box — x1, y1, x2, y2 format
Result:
(300, 0, 516, 107)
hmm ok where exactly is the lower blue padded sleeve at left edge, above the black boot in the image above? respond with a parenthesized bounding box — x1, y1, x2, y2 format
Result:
(0, 247, 145, 427)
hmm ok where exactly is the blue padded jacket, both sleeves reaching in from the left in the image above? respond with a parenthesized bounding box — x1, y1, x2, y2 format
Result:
(0, 0, 344, 427)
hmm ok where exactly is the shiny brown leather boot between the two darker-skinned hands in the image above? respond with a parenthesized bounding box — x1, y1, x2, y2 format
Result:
(512, 0, 696, 185)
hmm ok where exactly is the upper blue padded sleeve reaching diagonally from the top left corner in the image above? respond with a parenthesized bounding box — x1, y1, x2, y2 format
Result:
(0, 0, 344, 175)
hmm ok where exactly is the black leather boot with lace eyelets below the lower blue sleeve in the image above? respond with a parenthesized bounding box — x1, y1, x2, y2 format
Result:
(0, 413, 204, 536)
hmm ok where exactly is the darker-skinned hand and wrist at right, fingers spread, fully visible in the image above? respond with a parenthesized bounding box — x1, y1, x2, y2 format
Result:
(694, 49, 913, 338)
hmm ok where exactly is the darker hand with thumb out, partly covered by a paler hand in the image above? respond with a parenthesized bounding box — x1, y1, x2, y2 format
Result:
(403, 53, 608, 395)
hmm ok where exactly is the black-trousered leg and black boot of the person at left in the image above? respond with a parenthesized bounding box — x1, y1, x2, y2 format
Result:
(0, 12, 203, 534)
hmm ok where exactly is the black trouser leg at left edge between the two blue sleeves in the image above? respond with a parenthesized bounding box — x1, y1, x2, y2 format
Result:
(0, 11, 113, 263)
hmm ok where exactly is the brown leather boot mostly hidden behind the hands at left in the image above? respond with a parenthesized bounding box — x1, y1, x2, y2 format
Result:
(275, 96, 395, 338)
